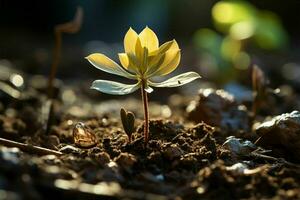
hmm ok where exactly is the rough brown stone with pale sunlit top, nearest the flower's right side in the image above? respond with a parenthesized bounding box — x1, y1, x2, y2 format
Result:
(186, 88, 250, 132)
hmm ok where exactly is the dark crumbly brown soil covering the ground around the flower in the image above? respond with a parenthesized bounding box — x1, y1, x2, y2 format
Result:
(0, 74, 300, 200)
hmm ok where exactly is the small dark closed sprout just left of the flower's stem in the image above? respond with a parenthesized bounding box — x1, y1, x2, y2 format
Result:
(120, 108, 135, 144)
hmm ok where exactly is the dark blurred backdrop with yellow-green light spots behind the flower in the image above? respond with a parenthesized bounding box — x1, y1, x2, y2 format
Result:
(0, 0, 300, 88)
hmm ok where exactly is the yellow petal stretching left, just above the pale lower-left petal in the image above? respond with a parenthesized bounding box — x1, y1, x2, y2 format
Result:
(86, 53, 135, 79)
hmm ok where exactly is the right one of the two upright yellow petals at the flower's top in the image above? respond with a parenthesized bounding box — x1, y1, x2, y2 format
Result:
(139, 26, 159, 52)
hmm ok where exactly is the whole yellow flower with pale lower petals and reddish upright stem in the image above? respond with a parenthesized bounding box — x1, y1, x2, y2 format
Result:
(86, 27, 200, 144)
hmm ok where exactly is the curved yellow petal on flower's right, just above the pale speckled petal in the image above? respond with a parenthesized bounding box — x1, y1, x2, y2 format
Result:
(151, 49, 181, 76)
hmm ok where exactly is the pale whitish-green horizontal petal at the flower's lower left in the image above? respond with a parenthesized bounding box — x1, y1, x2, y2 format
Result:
(91, 80, 140, 95)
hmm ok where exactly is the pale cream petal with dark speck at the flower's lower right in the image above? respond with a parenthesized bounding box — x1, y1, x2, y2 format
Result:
(148, 72, 201, 87)
